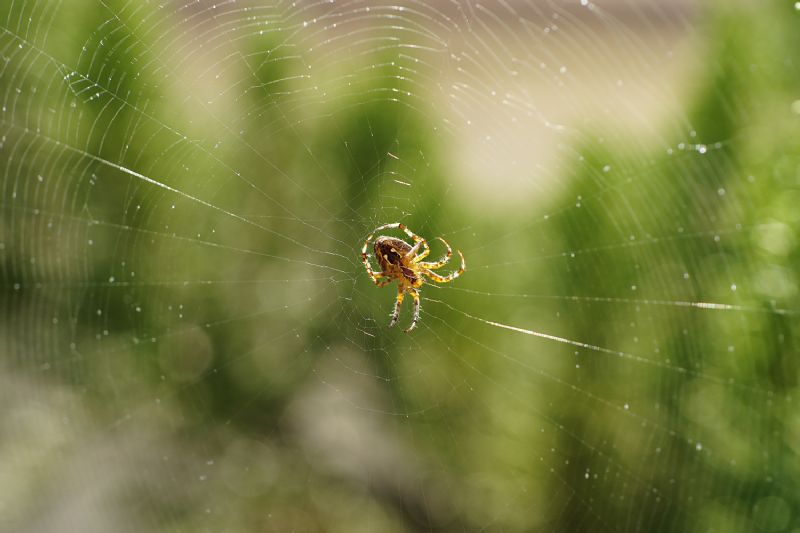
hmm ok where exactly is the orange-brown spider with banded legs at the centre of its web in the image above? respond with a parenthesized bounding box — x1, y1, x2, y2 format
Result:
(361, 222, 466, 333)
